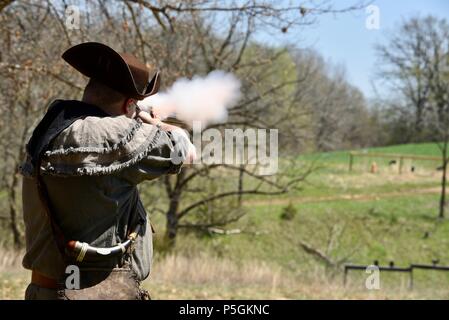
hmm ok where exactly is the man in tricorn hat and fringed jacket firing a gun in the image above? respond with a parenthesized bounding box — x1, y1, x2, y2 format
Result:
(21, 42, 194, 299)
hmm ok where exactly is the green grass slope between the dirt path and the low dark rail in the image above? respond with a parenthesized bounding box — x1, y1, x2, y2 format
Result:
(164, 195, 449, 271)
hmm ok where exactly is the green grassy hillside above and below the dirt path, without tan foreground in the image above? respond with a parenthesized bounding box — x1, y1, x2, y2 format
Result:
(148, 144, 449, 298)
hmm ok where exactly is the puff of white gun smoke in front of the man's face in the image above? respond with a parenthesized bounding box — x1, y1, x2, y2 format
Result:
(138, 70, 241, 125)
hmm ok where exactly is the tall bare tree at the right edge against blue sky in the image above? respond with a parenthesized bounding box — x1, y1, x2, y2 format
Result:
(379, 16, 449, 218)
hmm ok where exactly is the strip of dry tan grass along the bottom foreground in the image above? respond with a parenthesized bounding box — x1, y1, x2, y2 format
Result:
(0, 248, 449, 300)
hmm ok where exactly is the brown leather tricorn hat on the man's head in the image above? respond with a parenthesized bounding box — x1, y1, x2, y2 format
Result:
(62, 42, 160, 100)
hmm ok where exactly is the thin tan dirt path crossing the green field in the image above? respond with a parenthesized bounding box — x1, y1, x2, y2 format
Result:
(244, 187, 441, 206)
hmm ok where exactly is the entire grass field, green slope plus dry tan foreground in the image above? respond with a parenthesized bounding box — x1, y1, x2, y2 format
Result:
(0, 144, 449, 299)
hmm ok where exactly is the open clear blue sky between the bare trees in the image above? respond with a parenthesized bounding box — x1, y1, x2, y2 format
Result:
(260, 0, 449, 98)
